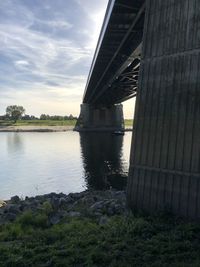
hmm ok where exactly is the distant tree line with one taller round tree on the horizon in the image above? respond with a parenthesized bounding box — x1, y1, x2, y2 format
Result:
(0, 105, 77, 122)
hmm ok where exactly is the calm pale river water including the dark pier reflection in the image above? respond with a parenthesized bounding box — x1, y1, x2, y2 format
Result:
(0, 131, 132, 199)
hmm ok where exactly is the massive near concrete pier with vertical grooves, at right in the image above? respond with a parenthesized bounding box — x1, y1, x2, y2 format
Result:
(127, 0, 200, 219)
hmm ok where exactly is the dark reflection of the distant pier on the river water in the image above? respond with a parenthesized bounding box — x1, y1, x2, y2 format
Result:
(80, 132, 127, 190)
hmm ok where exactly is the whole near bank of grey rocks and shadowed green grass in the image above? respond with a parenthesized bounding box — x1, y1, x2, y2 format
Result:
(0, 190, 200, 267)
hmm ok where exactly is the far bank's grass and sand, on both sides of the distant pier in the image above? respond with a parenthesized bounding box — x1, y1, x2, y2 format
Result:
(0, 119, 133, 132)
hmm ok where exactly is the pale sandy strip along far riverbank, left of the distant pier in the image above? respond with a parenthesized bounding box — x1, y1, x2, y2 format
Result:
(0, 126, 74, 132)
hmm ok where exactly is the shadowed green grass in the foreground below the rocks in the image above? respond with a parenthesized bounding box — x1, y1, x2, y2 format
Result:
(0, 212, 200, 267)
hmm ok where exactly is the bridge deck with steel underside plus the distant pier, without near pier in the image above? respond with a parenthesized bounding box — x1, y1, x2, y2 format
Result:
(77, 0, 145, 130)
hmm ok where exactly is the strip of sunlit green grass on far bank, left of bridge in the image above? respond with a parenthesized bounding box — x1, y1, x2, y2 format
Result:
(0, 120, 76, 126)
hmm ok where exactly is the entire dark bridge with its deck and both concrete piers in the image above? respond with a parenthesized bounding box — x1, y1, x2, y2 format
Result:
(76, 0, 200, 219)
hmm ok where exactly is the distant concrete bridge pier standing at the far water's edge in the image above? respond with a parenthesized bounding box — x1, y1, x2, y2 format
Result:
(75, 104, 124, 131)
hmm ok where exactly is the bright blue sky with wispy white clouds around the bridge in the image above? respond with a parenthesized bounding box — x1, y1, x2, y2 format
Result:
(0, 0, 134, 118)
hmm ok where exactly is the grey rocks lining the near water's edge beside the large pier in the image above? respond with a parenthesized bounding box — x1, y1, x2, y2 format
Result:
(0, 190, 127, 225)
